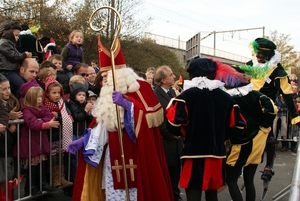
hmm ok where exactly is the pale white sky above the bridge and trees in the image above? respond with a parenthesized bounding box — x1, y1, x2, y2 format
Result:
(137, 0, 300, 57)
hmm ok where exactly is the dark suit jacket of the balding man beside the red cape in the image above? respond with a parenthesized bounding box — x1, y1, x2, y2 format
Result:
(154, 86, 183, 166)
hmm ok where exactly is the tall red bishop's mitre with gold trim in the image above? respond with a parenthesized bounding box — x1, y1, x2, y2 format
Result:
(98, 36, 126, 72)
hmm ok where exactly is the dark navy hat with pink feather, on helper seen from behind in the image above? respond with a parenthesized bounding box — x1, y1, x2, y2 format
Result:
(186, 58, 216, 77)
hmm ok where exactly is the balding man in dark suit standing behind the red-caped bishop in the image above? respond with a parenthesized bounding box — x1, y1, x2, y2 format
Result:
(154, 66, 183, 201)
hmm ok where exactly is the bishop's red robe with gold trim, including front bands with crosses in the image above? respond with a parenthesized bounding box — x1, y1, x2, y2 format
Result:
(72, 80, 174, 201)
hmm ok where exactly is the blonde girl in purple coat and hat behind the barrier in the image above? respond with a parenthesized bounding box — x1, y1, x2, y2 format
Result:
(14, 79, 59, 195)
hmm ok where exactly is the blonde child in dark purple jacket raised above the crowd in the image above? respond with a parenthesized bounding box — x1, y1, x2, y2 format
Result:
(61, 30, 83, 78)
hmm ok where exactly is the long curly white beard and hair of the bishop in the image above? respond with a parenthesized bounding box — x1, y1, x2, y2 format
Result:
(92, 68, 140, 132)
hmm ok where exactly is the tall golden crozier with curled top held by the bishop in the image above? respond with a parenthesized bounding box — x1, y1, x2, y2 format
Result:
(89, 6, 130, 201)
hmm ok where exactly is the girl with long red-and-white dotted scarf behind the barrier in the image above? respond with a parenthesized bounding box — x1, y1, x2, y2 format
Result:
(44, 76, 73, 187)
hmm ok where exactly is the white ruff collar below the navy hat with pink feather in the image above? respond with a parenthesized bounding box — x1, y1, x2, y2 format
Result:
(183, 77, 225, 91)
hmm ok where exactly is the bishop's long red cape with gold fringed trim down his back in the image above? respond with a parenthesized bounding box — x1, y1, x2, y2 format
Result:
(72, 81, 174, 201)
